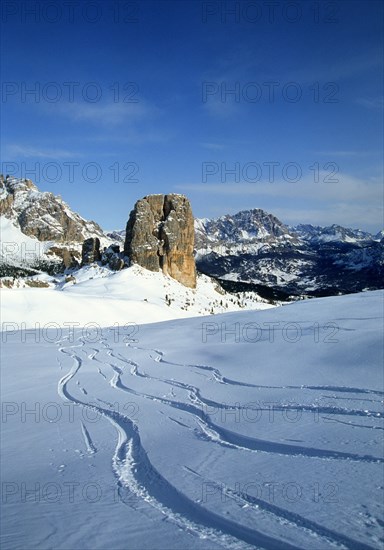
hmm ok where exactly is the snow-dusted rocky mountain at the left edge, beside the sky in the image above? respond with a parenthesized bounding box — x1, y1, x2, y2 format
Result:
(0, 175, 113, 276)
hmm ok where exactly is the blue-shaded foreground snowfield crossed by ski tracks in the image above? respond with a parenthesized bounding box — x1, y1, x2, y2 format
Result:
(1, 290, 384, 550)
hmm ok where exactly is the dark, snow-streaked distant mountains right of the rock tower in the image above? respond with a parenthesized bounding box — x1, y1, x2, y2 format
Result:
(195, 209, 384, 295)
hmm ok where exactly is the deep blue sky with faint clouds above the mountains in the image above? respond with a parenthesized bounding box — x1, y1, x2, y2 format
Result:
(1, 0, 383, 232)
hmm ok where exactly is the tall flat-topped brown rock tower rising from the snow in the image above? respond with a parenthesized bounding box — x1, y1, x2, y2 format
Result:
(124, 194, 196, 288)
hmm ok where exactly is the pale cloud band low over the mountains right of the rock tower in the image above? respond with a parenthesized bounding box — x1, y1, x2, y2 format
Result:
(175, 172, 383, 231)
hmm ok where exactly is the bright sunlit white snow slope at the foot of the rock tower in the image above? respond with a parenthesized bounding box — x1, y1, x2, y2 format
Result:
(1, 264, 273, 329)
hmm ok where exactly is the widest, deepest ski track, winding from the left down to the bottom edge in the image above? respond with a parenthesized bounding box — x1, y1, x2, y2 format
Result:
(58, 342, 278, 550)
